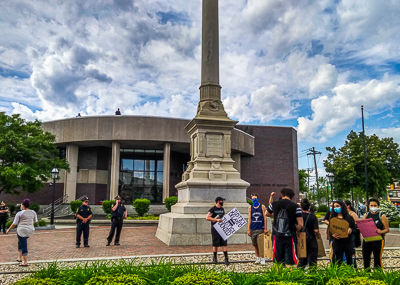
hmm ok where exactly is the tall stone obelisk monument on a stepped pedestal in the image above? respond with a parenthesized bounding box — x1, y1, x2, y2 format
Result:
(156, 0, 250, 245)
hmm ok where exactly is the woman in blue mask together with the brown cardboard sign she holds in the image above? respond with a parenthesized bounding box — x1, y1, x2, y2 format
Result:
(329, 200, 356, 265)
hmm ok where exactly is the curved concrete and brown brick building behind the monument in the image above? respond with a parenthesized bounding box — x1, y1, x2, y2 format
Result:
(0, 116, 298, 205)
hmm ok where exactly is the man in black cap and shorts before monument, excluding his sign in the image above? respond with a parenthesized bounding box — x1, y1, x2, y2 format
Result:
(206, 197, 229, 265)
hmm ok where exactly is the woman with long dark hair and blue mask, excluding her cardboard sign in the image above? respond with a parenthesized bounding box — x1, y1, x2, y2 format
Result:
(330, 200, 356, 265)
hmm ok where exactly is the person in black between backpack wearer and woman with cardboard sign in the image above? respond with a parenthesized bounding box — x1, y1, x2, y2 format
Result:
(297, 199, 319, 268)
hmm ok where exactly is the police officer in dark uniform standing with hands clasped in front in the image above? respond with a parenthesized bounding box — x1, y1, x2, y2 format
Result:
(76, 197, 93, 248)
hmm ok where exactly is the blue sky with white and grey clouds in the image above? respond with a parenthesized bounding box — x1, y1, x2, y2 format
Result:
(0, 0, 400, 178)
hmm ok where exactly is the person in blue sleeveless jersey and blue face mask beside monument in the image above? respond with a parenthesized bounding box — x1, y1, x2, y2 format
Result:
(247, 193, 268, 264)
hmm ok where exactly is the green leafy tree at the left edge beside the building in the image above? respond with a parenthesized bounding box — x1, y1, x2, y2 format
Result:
(0, 112, 69, 194)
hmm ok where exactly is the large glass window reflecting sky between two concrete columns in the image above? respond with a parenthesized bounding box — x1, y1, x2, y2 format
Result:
(119, 149, 164, 204)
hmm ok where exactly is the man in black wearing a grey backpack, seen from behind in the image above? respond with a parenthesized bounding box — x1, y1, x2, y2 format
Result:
(266, 188, 303, 267)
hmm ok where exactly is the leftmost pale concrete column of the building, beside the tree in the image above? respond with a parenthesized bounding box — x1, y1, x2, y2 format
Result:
(63, 144, 79, 202)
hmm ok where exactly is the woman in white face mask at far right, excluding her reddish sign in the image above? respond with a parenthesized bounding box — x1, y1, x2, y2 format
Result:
(362, 198, 390, 269)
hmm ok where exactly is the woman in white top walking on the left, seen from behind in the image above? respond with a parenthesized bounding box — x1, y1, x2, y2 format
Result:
(6, 199, 38, 266)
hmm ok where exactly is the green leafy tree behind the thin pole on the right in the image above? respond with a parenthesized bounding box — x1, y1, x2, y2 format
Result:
(324, 131, 400, 198)
